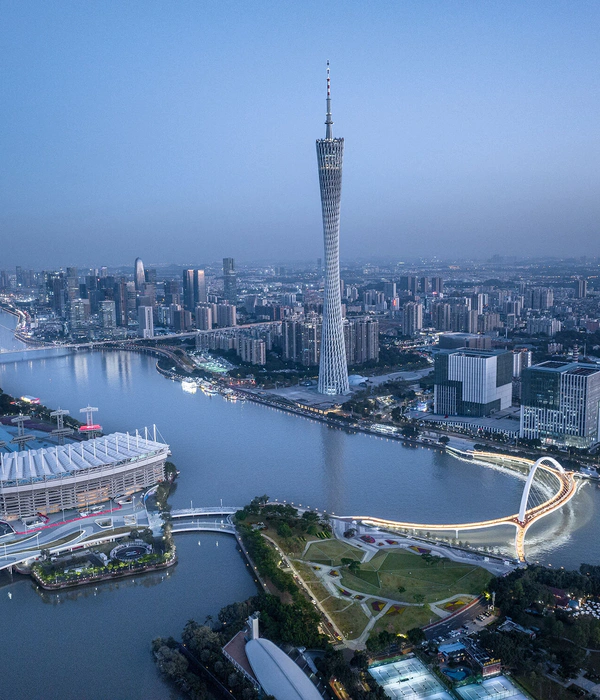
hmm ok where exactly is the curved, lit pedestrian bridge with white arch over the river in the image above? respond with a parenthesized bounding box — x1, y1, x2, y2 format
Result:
(340, 453, 577, 562)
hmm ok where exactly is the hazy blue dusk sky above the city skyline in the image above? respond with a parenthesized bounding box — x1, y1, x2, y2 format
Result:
(0, 2, 600, 268)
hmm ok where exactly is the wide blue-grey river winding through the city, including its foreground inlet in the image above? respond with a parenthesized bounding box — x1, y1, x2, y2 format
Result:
(0, 314, 600, 700)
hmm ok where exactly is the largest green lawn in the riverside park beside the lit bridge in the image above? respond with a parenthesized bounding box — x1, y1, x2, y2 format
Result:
(341, 550, 492, 603)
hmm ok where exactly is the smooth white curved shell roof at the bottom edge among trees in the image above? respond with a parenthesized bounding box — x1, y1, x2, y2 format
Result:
(246, 639, 321, 700)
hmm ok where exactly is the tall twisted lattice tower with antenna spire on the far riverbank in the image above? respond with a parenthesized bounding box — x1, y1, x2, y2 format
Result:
(317, 61, 350, 396)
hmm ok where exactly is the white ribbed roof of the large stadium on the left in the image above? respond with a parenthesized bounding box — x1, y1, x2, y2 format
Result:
(0, 433, 169, 483)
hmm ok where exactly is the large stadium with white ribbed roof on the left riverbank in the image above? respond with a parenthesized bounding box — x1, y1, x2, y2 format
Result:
(0, 431, 169, 520)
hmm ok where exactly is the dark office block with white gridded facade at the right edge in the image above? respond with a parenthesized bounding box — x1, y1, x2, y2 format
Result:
(520, 361, 600, 448)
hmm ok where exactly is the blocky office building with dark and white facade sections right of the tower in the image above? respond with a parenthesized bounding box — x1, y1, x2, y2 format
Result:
(433, 349, 513, 416)
